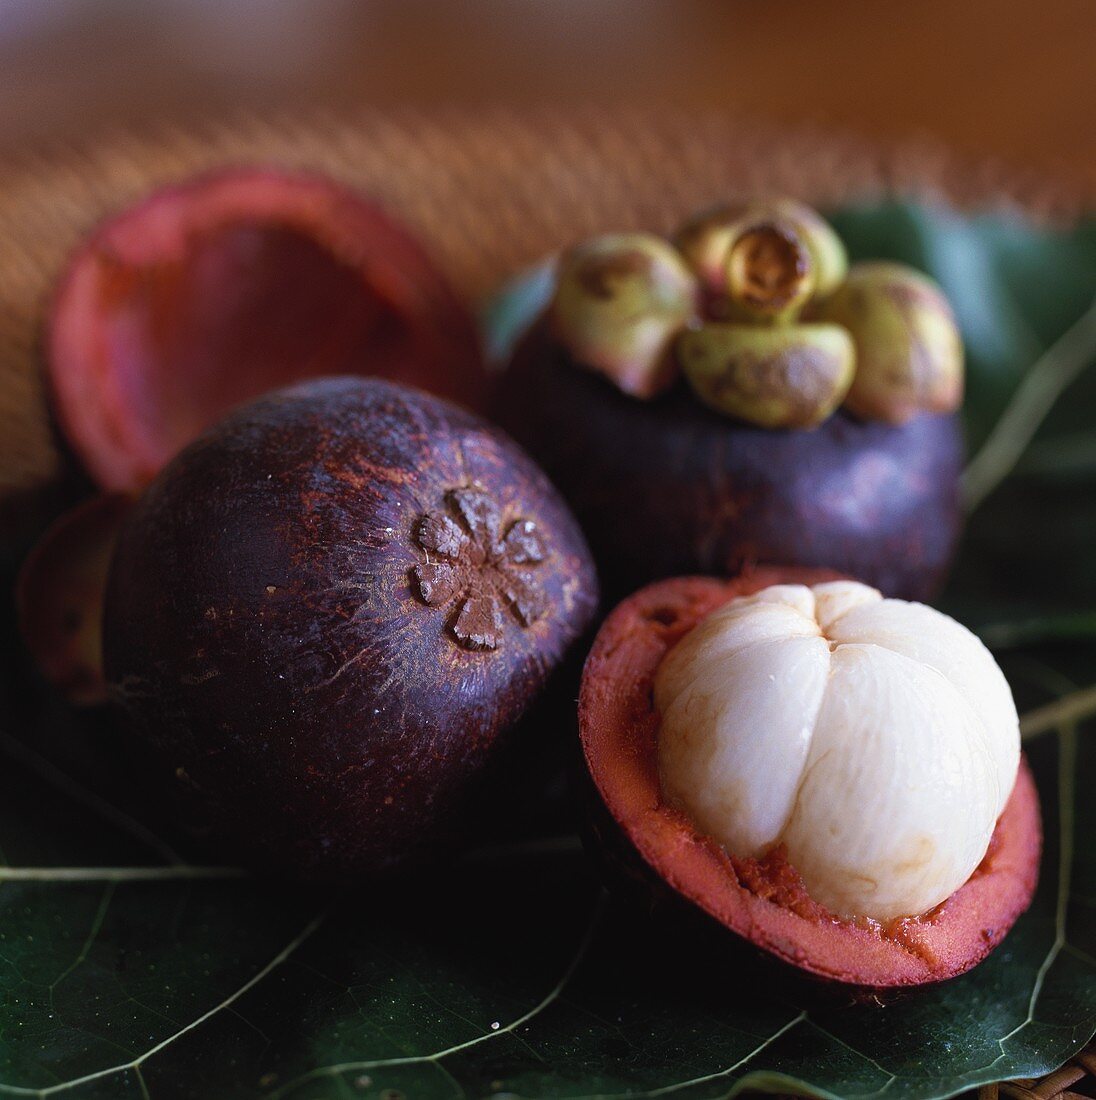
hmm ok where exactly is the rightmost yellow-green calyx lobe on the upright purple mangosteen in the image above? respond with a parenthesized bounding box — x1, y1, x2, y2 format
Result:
(812, 262, 963, 425)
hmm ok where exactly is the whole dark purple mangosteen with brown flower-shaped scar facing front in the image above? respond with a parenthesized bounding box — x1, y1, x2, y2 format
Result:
(103, 378, 598, 880)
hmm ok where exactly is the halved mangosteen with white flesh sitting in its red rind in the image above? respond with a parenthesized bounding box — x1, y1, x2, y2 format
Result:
(579, 569, 1041, 989)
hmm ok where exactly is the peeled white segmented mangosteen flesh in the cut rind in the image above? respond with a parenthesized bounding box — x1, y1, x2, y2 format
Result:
(655, 582, 1020, 921)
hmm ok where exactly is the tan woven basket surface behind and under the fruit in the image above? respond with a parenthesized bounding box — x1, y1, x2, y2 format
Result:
(0, 110, 1096, 1100)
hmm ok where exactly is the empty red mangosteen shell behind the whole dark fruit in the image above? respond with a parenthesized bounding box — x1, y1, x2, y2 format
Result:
(45, 167, 486, 491)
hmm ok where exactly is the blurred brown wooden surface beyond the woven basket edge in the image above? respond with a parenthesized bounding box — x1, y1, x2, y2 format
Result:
(0, 0, 1096, 199)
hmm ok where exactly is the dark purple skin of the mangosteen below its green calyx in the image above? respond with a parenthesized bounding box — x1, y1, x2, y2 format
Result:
(496, 327, 963, 601)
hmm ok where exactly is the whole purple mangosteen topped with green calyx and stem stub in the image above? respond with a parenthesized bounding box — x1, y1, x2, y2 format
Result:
(495, 200, 963, 600)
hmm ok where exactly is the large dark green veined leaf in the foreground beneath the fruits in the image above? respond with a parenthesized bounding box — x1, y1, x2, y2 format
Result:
(0, 686, 1096, 1100)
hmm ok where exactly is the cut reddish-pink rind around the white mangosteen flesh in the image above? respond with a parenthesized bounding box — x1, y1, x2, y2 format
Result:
(579, 568, 1042, 990)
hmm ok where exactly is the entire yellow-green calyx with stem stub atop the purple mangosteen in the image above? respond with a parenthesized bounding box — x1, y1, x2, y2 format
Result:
(548, 199, 963, 428)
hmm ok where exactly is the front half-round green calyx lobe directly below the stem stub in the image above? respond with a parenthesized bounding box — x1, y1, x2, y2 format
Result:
(678, 322, 856, 428)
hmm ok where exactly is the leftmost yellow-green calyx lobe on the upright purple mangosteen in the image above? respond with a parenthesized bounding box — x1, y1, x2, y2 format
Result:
(547, 233, 698, 397)
